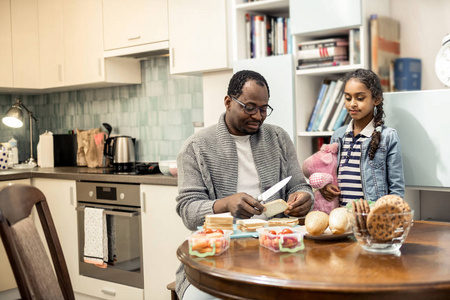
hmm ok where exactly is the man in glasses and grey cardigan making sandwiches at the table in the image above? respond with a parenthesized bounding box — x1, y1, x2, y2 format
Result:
(176, 70, 313, 300)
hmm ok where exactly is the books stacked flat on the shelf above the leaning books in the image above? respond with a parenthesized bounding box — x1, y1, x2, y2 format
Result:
(297, 29, 360, 70)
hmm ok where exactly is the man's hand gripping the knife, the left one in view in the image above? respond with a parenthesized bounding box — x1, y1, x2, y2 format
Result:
(213, 193, 266, 219)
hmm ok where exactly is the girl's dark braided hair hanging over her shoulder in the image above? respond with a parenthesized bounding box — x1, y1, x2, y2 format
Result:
(342, 69, 384, 160)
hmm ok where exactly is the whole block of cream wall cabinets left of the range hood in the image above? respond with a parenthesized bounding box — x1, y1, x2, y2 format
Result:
(0, 0, 141, 93)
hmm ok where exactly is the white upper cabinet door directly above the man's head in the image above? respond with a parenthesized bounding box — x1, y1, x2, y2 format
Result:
(169, 0, 229, 74)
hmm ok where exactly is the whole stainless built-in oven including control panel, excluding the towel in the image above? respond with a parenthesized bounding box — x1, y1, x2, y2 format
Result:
(76, 181, 144, 288)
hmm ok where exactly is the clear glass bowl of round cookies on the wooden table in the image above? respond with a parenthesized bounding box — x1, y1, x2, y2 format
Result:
(349, 211, 414, 254)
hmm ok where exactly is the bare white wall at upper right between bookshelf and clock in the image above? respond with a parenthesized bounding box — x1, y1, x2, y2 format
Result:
(391, 0, 450, 90)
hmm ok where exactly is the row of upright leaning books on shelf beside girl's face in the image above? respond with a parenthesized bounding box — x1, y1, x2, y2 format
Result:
(306, 79, 350, 131)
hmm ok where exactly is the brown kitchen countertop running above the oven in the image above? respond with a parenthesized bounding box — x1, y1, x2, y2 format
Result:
(0, 167, 177, 186)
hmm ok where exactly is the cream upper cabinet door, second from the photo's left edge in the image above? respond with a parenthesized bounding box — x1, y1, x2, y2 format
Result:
(11, 0, 40, 88)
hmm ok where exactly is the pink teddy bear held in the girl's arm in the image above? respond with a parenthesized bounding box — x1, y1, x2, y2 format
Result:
(303, 143, 339, 214)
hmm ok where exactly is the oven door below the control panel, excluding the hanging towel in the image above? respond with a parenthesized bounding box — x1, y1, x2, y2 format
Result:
(77, 202, 144, 288)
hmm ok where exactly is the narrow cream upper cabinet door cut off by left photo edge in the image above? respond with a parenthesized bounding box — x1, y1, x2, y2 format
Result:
(0, 0, 13, 87)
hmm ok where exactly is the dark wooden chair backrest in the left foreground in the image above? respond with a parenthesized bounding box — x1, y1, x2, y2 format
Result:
(0, 184, 75, 300)
